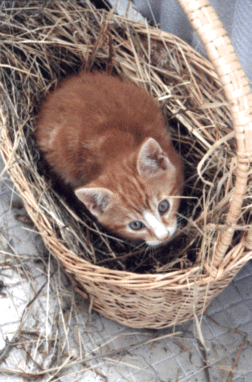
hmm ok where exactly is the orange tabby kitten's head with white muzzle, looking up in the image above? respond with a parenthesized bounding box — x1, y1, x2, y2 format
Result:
(75, 138, 183, 246)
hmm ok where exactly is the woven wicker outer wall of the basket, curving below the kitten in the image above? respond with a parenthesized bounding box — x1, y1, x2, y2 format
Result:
(2, 124, 251, 329)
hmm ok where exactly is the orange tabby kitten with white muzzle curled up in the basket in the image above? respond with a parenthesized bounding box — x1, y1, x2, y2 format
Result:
(36, 72, 183, 246)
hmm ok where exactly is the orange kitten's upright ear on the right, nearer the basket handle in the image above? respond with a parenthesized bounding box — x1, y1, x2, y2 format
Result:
(137, 138, 173, 176)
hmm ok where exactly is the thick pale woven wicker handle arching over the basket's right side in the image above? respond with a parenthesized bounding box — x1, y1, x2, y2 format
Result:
(177, 0, 252, 267)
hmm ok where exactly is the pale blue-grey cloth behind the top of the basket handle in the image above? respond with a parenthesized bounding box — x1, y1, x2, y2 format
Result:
(133, 0, 252, 82)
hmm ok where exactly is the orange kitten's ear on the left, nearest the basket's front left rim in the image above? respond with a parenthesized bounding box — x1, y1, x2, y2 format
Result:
(74, 187, 113, 217)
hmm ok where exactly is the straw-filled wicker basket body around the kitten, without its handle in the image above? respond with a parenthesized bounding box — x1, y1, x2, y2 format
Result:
(0, 1, 252, 328)
